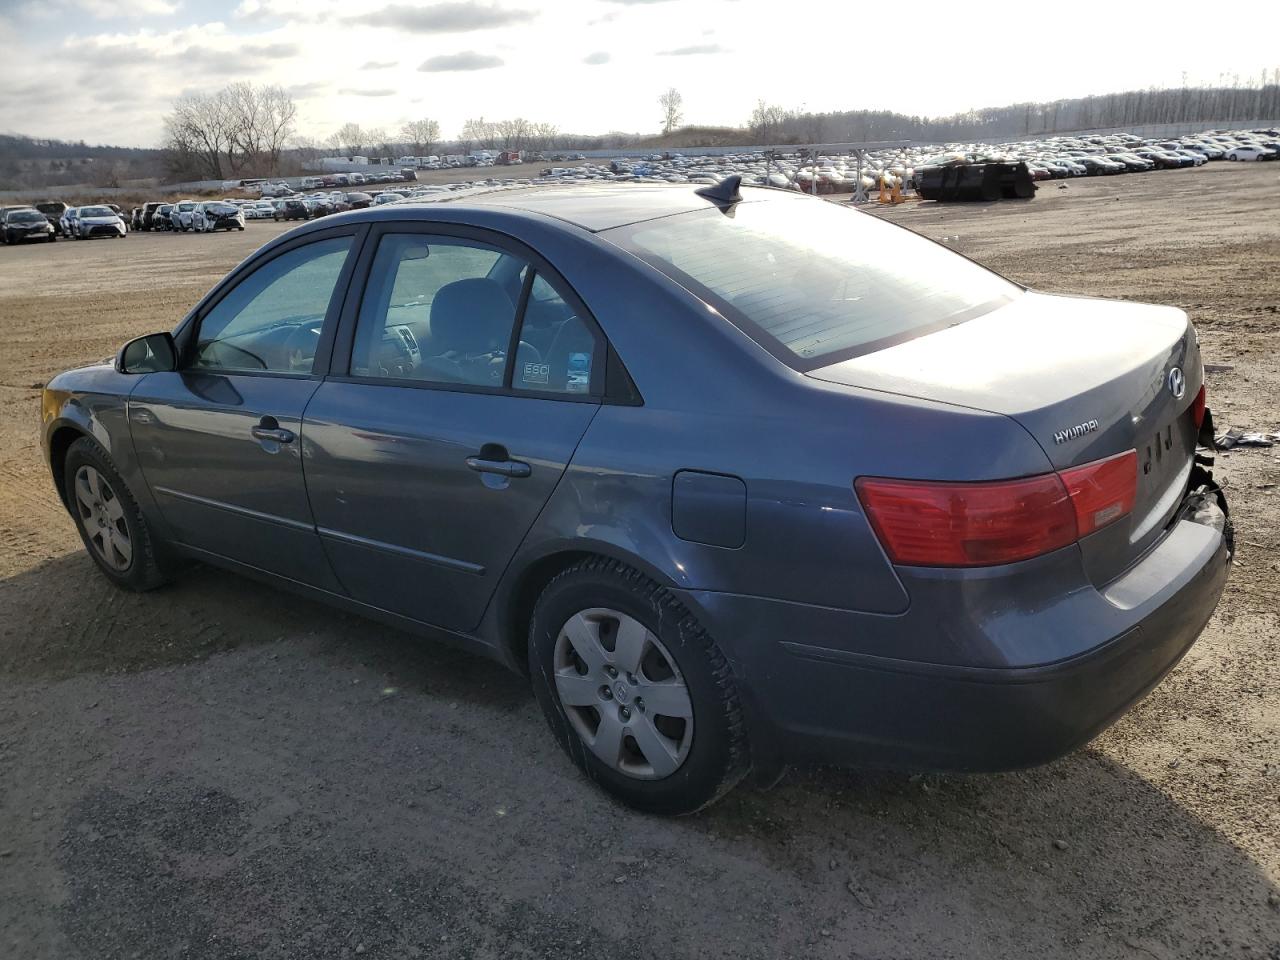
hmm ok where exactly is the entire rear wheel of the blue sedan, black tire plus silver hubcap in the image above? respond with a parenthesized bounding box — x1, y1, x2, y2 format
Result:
(529, 557, 750, 815)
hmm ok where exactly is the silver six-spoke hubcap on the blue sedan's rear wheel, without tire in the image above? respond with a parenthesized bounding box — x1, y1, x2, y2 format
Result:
(553, 607, 694, 780)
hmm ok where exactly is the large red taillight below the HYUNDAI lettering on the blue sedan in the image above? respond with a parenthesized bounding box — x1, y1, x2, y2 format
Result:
(855, 451, 1138, 567)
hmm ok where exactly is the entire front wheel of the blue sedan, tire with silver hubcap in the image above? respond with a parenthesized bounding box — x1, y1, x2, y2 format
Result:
(63, 436, 168, 593)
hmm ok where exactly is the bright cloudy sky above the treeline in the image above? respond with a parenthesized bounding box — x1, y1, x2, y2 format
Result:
(0, 0, 1280, 146)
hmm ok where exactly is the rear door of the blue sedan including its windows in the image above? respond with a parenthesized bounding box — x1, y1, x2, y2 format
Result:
(303, 224, 604, 631)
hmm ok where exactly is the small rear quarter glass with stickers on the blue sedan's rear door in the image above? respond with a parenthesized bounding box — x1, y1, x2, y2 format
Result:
(511, 274, 595, 393)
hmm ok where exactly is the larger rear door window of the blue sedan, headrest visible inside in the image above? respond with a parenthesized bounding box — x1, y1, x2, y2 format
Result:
(351, 233, 526, 387)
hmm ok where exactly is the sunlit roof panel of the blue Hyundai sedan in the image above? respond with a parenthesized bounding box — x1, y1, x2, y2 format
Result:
(383, 183, 709, 233)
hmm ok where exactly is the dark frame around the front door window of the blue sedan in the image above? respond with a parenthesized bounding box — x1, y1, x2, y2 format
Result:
(173, 224, 369, 380)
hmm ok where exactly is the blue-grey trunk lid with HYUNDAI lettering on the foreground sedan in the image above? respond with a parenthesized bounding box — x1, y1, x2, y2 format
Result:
(809, 293, 1203, 585)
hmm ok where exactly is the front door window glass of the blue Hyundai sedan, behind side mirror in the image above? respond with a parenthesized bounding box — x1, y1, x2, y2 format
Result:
(192, 237, 351, 374)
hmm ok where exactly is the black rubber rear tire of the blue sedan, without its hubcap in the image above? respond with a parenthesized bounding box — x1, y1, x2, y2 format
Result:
(529, 563, 745, 814)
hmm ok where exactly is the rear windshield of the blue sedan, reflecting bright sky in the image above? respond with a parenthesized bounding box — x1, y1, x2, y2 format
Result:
(603, 197, 1021, 370)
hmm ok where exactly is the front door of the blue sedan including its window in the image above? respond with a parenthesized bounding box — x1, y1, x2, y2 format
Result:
(129, 234, 353, 590)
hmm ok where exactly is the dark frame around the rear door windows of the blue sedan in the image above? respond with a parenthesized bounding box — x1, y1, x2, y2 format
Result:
(325, 220, 614, 403)
